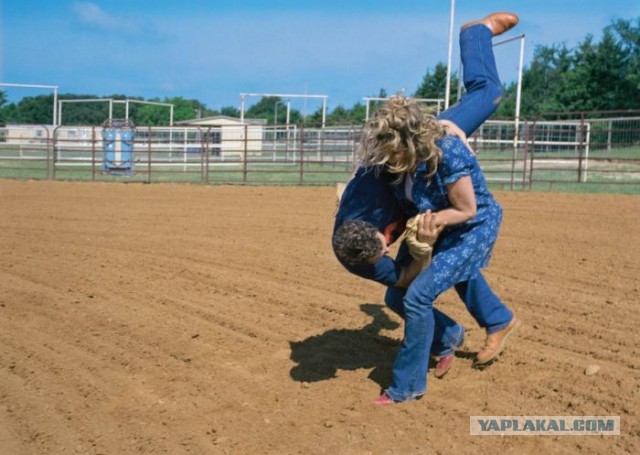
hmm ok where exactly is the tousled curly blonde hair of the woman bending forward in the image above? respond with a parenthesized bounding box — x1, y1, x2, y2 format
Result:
(361, 96, 445, 180)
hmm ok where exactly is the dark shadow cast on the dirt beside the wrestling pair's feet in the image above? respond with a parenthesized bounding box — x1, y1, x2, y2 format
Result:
(289, 303, 400, 387)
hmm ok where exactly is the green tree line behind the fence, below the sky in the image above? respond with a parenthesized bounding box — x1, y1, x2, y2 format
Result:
(0, 18, 640, 125)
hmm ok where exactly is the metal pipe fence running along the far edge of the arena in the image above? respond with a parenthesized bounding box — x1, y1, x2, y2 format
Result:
(0, 113, 640, 193)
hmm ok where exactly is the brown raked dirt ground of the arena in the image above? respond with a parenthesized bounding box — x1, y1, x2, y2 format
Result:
(0, 181, 640, 455)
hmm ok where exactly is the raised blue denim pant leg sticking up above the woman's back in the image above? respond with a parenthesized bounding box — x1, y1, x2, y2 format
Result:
(438, 24, 504, 136)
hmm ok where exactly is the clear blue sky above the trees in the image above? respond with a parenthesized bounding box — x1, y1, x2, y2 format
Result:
(0, 0, 640, 110)
